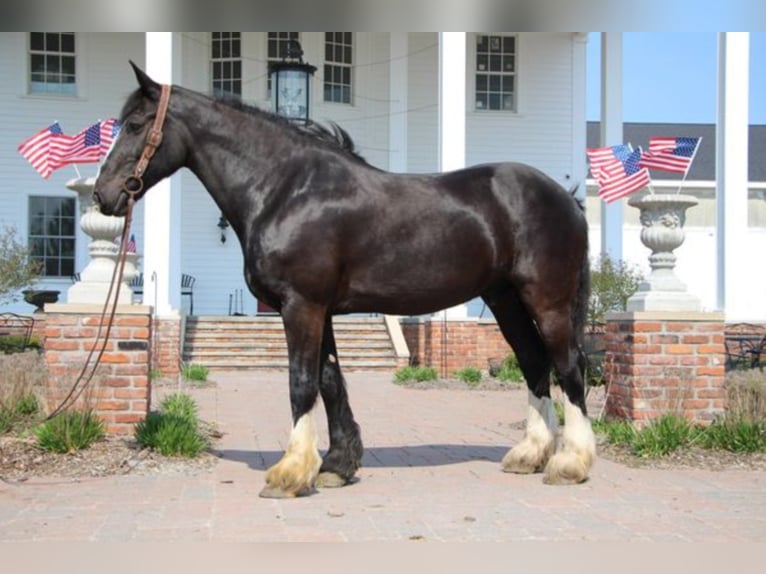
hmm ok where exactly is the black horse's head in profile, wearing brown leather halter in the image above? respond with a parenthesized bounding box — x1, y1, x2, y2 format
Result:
(93, 62, 185, 215)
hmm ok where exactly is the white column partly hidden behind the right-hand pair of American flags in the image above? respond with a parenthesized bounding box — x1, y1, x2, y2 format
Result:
(601, 32, 625, 260)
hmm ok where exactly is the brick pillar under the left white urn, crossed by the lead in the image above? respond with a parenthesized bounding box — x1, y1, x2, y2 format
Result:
(45, 303, 151, 435)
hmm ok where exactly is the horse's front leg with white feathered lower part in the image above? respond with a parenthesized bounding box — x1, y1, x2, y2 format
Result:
(260, 303, 325, 498)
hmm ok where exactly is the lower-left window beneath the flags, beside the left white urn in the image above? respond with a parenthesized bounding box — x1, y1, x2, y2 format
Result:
(29, 197, 76, 277)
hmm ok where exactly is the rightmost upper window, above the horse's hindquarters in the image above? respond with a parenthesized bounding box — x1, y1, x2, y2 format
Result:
(476, 35, 517, 112)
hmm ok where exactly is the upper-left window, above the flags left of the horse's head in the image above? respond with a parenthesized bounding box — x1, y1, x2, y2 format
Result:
(29, 32, 77, 95)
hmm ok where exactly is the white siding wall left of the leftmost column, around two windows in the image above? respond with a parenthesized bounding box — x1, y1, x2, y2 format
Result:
(0, 32, 144, 313)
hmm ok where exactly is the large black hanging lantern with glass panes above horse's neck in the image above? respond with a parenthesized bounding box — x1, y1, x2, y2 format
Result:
(269, 40, 316, 124)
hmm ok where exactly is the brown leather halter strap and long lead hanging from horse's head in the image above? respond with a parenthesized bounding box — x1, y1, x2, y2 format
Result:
(46, 84, 170, 420)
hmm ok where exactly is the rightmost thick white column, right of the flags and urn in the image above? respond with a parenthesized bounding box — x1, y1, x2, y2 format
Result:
(716, 32, 762, 321)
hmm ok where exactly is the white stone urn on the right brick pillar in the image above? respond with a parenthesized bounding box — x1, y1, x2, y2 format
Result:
(627, 194, 700, 311)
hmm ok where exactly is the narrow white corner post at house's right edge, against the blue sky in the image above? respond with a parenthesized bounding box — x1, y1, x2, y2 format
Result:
(568, 32, 588, 204)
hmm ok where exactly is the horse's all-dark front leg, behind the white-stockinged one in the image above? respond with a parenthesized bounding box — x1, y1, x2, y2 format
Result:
(316, 315, 363, 488)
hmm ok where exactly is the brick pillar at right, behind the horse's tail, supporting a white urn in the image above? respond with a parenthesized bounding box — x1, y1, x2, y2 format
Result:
(604, 311, 725, 427)
